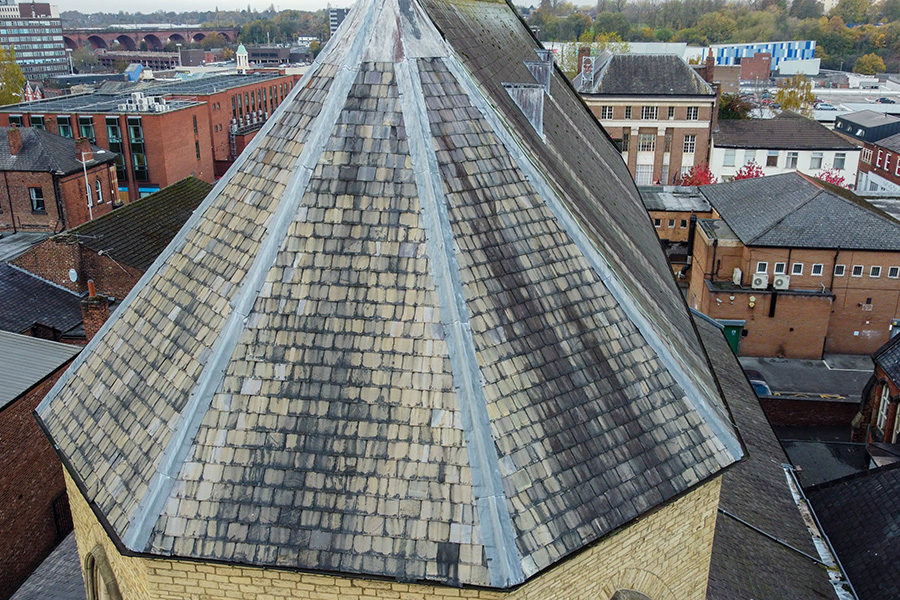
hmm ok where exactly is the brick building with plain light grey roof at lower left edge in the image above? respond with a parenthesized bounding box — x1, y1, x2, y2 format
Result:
(0, 331, 81, 599)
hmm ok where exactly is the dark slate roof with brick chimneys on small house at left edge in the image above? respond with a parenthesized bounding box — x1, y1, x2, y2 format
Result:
(0, 127, 116, 175)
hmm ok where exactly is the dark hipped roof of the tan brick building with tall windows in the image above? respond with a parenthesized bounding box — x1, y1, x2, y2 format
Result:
(572, 52, 715, 96)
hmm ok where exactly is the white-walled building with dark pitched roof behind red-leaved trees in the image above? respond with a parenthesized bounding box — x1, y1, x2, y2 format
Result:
(709, 111, 860, 184)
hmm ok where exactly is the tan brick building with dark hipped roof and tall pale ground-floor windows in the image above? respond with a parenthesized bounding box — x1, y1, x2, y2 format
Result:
(573, 52, 718, 185)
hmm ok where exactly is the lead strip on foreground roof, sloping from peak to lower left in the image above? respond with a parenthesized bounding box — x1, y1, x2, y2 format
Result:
(122, 2, 376, 551)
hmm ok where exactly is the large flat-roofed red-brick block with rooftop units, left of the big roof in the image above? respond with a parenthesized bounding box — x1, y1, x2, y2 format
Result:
(0, 72, 296, 202)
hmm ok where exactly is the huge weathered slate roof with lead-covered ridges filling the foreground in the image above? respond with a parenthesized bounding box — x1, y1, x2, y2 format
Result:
(39, 0, 741, 588)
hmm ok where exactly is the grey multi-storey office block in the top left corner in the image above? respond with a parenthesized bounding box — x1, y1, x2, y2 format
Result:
(0, 0, 70, 81)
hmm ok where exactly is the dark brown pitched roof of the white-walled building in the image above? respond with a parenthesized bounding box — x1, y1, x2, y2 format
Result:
(713, 111, 859, 152)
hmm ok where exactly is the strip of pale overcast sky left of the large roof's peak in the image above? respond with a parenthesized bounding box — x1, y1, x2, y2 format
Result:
(59, 0, 353, 14)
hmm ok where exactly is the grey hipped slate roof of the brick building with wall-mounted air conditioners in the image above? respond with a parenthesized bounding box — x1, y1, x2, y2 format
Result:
(700, 172, 900, 250)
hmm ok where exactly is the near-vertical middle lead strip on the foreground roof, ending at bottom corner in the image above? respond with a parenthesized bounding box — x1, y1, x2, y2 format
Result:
(395, 58, 525, 588)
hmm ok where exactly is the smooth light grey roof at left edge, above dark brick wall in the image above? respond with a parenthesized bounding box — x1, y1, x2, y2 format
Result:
(0, 331, 81, 409)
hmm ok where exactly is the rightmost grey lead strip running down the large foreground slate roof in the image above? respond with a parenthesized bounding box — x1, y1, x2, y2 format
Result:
(444, 57, 744, 466)
